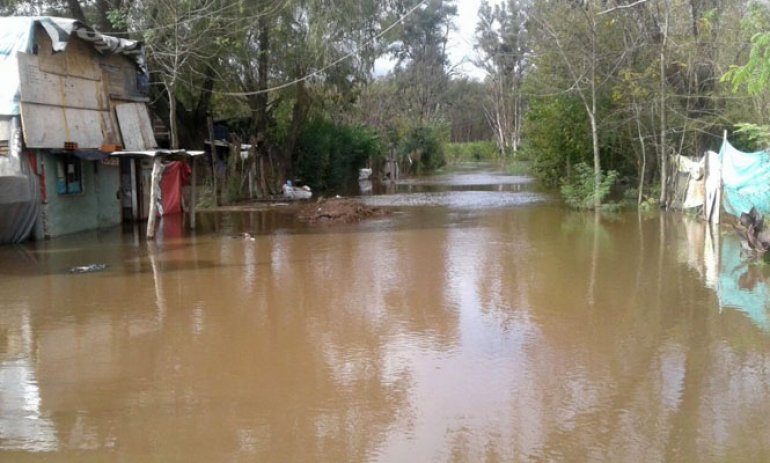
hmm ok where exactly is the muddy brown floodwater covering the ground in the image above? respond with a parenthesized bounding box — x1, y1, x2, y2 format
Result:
(0, 165, 770, 462)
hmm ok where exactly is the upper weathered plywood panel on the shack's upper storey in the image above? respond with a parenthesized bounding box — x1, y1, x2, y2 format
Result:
(18, 53, 108, 110)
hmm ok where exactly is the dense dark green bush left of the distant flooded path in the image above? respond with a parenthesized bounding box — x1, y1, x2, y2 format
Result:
(295, 119, 381, 191)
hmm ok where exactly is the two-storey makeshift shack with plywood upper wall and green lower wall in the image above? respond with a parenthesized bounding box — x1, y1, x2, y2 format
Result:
(0, 17, 156, 243)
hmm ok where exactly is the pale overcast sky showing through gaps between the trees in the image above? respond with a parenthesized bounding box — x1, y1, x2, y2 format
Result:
(374, 0, 486, 79)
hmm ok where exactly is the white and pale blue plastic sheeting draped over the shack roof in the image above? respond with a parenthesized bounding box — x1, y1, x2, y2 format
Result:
(0, 16, 147, 115)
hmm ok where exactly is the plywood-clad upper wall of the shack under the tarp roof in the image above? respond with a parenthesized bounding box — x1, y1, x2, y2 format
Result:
(18, 26, 155, 149)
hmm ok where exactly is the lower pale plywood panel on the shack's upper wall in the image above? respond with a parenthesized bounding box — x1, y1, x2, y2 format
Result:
(21, 102, 117, 149)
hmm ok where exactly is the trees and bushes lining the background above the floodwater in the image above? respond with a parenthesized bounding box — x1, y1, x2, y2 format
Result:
(7, 0, 770, 207)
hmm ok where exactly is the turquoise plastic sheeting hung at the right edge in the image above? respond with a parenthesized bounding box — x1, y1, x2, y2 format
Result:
(719, 140, 770, 217)
